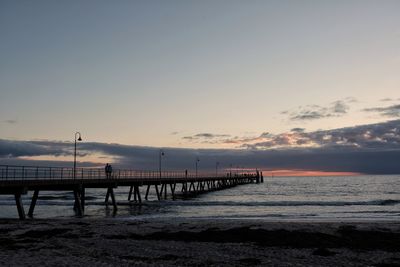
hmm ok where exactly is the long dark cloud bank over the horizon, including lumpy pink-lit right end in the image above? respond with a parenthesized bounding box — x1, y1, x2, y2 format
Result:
(0, 120, 400, 174)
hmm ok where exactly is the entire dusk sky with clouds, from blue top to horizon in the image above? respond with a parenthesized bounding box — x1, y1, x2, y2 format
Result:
(0, 0, 400, 174)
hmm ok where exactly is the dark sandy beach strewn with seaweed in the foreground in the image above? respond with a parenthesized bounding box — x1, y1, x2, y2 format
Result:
(0, 218, 400, 267)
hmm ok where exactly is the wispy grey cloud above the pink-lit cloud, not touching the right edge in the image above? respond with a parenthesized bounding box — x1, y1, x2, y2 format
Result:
(281, 98, 357, 121)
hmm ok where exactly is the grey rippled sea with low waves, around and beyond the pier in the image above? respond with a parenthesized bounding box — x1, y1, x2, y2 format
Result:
(0, 175, 400, 221)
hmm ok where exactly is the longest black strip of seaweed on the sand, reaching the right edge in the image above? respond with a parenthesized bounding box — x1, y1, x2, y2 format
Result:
(126, 227, 400, 251)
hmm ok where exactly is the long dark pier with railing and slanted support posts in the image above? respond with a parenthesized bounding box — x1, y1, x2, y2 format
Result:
(0, 165, 263, 220)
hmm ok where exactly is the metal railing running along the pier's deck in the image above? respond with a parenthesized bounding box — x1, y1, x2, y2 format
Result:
(0, 165, 256, 181)
